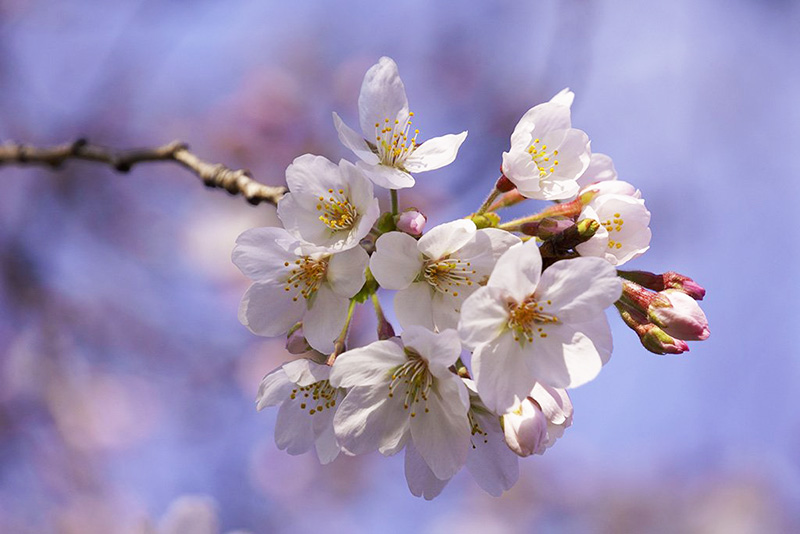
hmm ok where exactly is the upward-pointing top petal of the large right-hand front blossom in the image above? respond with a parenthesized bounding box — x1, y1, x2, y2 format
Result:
(486, 239, 542, 302)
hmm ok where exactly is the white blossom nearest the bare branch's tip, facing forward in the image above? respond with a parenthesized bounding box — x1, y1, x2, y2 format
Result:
(278, 154, 380, 251)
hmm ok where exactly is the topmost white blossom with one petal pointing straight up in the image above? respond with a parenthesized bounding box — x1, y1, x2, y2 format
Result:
(333, 57, 467, 189)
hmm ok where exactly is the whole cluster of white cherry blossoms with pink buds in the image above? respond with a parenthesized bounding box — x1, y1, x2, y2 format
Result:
(233, 57, 709, 499)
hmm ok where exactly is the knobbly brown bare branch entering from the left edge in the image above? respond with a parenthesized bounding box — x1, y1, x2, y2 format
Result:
(0, 139, 286, 205)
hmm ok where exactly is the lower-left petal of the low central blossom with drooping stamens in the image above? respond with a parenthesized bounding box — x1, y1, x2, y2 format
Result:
(333, 384, 408, 454)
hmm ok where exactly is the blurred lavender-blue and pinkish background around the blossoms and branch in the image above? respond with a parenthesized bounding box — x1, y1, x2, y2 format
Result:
(0, 0, 800, 534)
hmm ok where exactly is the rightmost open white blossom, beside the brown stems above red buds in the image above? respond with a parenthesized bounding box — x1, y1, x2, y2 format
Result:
(575, 194, 652, 266)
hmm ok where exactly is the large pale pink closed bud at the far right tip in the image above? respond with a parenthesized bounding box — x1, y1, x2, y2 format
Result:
(647, 289, 711, 341)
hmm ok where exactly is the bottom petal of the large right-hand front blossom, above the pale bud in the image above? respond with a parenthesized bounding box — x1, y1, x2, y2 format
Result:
(472, 332, 536, 413)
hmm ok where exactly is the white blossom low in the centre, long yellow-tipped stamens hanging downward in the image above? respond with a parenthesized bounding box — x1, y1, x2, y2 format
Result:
(330, 327, 470, 480)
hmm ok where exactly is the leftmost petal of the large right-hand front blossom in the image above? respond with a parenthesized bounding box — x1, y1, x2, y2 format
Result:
(458, 287, 509, 350)
